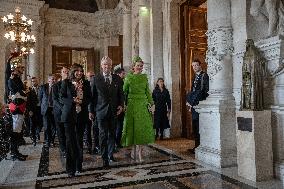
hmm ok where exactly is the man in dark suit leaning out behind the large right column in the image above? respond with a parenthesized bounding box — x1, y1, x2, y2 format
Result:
(186, 60, 209, 153)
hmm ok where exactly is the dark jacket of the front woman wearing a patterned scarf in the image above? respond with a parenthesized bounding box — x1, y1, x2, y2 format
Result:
(60, 79, 91, 122)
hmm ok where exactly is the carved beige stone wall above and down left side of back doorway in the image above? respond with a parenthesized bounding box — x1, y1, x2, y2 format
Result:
(44, 8, 122, 79)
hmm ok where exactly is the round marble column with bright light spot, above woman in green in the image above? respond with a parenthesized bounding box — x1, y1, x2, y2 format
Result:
(138, 0, 151, 76)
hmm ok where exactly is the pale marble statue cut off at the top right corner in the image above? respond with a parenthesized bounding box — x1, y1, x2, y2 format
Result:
(250, 0, 284, 37)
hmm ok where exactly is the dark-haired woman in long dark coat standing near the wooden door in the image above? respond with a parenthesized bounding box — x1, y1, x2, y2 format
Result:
(152, 78, 171, 140)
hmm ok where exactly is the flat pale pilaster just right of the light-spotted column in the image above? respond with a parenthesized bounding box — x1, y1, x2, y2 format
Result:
(150, 0, 164, 87)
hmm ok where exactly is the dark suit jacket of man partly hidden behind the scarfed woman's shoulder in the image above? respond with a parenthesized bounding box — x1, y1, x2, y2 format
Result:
(52, 81, 63, 122)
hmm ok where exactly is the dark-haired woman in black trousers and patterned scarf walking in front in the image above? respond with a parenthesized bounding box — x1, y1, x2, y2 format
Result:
(60, 64, 91, 176)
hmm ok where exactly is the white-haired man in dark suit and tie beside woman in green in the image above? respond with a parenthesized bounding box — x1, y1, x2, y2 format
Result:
(89, 57, 124, 167)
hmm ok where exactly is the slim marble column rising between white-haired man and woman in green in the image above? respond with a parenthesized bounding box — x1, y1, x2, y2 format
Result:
(122, 2, 132, 71)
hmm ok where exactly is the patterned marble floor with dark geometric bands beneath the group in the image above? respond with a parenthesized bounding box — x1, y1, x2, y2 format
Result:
(0, 137, 280, 189)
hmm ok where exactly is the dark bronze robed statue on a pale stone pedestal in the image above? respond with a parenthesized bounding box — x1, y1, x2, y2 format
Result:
(240, 39, 267, 110)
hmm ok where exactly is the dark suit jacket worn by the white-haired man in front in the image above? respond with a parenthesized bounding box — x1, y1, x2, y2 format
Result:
(89, 73, 124, 119)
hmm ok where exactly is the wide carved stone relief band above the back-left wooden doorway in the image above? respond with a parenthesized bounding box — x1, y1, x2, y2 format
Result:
(45, 9, 122, 39)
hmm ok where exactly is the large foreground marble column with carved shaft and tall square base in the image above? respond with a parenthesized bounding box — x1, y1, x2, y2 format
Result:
(195, 0, 237, 167)
